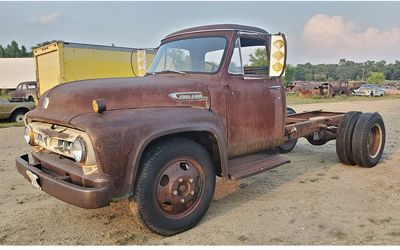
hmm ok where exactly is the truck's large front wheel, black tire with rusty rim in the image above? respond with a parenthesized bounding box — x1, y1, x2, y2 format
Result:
(135, 138, 215, 236)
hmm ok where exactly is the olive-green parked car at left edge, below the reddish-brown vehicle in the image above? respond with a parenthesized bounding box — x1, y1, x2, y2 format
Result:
(0, 98, 35, 123)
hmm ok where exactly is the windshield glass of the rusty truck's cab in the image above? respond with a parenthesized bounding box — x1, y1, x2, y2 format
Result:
(148, 37, 226, 73)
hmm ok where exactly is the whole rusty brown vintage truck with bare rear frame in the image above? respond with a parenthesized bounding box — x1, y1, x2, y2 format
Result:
(16, 24, 385, 235)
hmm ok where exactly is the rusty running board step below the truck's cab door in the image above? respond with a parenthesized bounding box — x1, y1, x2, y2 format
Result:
(228, 153, 290, 180)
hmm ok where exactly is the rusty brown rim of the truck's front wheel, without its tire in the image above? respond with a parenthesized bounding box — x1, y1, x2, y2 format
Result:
(155, 157, 205, 217)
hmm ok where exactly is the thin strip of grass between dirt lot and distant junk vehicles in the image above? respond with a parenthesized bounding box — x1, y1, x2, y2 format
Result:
(286, 95, 400, 105)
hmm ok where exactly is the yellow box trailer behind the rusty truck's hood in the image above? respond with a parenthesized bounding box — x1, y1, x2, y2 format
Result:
(33, 42, 155, 96)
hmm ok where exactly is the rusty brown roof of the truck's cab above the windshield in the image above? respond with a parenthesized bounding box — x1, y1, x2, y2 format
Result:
(163, 24, 269, 40)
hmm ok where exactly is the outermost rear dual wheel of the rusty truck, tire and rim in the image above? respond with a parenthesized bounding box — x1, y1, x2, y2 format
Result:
(352, 113, 386, 168)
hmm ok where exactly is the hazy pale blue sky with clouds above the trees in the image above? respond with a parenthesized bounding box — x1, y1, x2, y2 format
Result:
(0, 2, 400, 64)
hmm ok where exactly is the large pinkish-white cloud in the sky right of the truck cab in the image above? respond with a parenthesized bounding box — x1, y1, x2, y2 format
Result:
(302, 14, 400, 60)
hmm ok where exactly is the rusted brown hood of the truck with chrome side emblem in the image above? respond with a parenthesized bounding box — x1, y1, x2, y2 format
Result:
(27, 74, 210, 125)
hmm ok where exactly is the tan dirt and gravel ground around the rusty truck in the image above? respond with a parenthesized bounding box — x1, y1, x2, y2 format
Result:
(0, 100, 400, 245)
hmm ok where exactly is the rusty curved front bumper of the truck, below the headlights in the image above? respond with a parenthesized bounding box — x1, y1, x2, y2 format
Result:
(15, 152, 110, 208)
